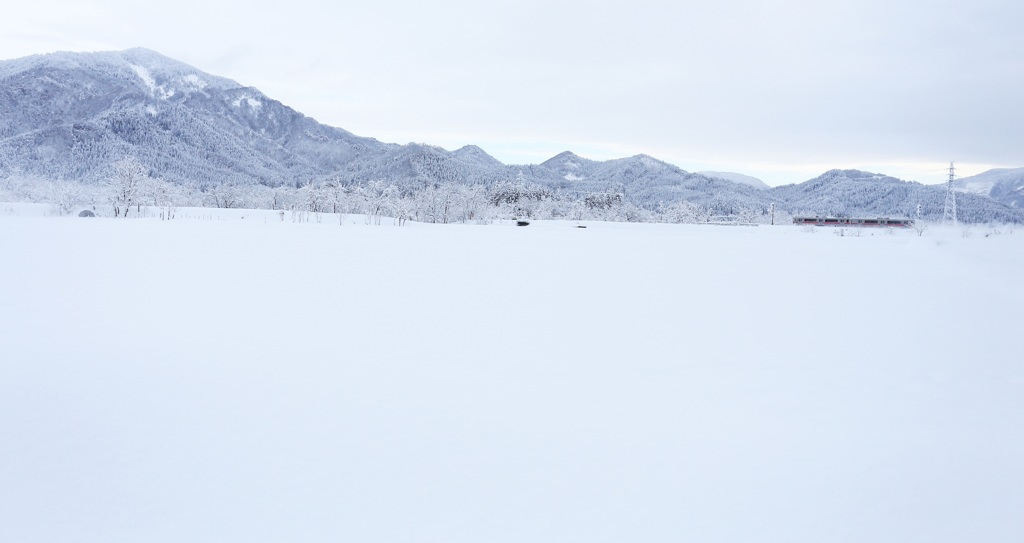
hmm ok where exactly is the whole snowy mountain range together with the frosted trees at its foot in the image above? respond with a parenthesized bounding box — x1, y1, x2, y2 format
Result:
(0, 49, 1024, 222)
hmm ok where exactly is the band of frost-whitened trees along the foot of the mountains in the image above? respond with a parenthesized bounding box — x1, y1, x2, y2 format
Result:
(0, 159, 790, 224)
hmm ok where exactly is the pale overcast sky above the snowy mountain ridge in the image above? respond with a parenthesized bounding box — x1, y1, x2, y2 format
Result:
(0, 0, 1024, 184)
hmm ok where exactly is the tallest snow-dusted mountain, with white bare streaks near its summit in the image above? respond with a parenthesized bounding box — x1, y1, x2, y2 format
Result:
(0, 49, 390, 185)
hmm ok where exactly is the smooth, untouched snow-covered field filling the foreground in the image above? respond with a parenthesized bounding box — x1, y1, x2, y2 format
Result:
(0, 204, 1024, 543)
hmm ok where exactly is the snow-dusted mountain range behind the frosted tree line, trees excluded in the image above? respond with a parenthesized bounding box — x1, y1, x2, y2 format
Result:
(0, 49, 1024, 221)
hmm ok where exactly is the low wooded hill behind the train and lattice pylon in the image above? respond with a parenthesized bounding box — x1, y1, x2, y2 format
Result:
(769, 166, 1024, 222)
